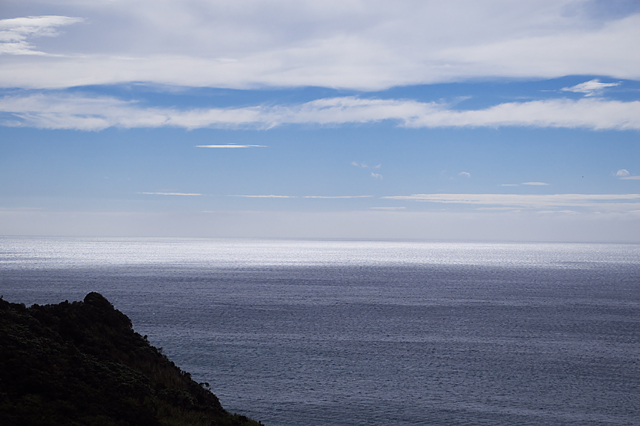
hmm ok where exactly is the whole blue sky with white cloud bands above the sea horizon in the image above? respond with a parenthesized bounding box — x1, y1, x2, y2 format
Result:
(0, 0, 640, 243)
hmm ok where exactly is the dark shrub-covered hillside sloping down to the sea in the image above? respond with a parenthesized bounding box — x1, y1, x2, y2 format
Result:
(0, 293, 259, 426)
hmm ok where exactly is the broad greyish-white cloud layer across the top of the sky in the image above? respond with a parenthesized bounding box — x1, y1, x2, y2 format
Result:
(0, 0, 640, 90)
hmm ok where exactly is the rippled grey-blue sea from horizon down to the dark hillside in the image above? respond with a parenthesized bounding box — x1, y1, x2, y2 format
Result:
(0, 237, 640, 426)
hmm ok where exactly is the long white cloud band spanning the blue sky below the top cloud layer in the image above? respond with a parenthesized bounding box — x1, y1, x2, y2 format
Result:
(0, 93, 640, 131)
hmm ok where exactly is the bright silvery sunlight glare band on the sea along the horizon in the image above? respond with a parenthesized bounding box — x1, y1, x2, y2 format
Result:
(0, 237, 640, 268)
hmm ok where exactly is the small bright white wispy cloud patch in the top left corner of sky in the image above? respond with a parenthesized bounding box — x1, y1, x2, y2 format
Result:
(0, 16, 83, 55)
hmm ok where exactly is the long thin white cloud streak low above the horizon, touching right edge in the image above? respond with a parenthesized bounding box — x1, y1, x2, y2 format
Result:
(382, 194, 640, 211)
